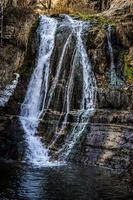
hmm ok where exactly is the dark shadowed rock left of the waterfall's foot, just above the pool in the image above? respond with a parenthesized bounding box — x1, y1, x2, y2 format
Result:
(0, 116, 25, 160)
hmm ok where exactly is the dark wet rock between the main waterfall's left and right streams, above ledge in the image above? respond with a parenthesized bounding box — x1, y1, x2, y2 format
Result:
(46, 16, 88, 113)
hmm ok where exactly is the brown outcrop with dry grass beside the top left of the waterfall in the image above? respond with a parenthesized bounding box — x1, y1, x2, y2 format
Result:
(0, 3, 37, 89)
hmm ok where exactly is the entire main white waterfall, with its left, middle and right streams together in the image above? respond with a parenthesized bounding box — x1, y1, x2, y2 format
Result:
(20, 15, 96, 166)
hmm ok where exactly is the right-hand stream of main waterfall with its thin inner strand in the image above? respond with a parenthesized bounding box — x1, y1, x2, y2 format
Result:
(50, 15, 96, 155)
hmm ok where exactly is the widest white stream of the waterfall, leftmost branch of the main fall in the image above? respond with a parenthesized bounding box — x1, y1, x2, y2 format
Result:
(20, 16, 57, 165)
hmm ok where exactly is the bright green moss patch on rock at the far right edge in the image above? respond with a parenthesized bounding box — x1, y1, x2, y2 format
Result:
(124, 64, 133, 83)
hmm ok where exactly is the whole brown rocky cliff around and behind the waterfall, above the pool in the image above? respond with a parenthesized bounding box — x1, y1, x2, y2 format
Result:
(0, 0, 133, 172)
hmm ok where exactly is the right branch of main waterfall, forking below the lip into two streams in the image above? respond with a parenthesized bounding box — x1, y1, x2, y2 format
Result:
(59, 17, 96, 159)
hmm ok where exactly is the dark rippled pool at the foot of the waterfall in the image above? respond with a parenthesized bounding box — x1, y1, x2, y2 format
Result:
(0, 163, 133, 200)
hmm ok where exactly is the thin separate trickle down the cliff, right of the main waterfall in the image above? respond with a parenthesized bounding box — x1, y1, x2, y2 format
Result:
(107, 25, 123, 86)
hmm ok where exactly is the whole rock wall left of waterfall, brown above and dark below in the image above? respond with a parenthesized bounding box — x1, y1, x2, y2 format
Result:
(0, 1, 38, 159)
